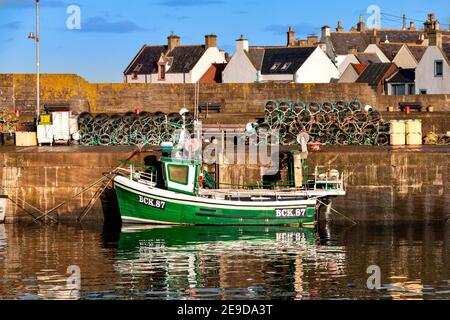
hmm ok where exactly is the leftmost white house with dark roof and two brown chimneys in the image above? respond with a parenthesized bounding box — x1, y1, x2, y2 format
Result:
(124, 35, 226, 83)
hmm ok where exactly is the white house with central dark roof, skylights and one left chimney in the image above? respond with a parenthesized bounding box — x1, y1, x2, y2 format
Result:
(222, 37, 339, 83)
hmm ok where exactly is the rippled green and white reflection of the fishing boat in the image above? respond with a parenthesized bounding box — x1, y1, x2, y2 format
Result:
(115, 226, 345, 299)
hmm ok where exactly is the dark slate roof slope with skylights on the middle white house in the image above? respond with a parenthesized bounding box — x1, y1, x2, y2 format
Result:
(261, 47, 316, 74)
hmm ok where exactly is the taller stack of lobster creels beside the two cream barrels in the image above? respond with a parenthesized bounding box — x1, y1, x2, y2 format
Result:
(256, 100, 389, 145)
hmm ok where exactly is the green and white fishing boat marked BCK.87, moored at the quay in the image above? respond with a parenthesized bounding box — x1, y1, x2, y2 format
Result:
(114, 109, 345, 226)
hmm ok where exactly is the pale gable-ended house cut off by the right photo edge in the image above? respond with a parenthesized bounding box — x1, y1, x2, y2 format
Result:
(416, 43, 450, 94)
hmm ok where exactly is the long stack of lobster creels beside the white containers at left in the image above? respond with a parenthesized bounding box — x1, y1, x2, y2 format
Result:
(78, 112, 194, 146)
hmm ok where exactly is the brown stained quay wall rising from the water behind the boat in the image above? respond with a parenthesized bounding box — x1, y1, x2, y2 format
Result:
(0, 146, 450, 223)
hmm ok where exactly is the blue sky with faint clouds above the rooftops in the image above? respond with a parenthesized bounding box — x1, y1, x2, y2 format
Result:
(0, 0, 450, 82)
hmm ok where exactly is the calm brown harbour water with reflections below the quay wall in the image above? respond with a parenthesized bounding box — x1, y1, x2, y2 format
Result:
(0, 224, 450, 299)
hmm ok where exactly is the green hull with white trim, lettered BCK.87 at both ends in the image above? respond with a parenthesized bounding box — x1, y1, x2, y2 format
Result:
(114, 176, 316, 226)
